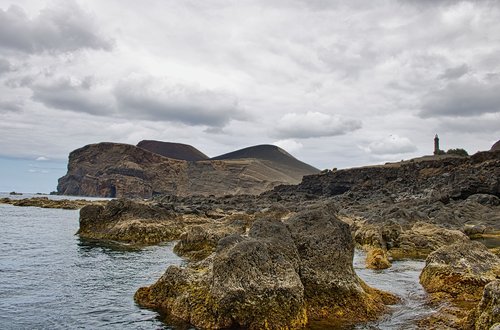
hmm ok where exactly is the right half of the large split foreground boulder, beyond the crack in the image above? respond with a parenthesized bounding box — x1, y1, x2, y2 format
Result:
(287, 205, 394, 321)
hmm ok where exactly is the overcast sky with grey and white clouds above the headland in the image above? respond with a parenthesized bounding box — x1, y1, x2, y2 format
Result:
(0, 0, 500, 192)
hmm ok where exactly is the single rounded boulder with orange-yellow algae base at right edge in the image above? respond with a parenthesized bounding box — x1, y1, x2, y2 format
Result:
(420, 241, 500, 301)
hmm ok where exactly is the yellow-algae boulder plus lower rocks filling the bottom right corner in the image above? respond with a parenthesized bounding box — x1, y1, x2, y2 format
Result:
(420, 242, 500, 329)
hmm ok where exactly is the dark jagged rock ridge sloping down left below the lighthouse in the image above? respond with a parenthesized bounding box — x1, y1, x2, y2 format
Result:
(275, 151, 500, 202)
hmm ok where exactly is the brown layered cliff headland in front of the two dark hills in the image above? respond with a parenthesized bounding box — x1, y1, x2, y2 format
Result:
(57, 143, 318, 198)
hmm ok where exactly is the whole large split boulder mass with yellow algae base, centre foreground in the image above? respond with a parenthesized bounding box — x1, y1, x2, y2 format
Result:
(135, 207, 395, 329)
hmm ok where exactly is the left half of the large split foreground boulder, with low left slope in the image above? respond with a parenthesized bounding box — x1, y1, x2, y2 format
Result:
(135, 219, 307, 329)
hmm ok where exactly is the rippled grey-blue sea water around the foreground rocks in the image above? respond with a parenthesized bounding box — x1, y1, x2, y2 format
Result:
(0, 195, 433, 329)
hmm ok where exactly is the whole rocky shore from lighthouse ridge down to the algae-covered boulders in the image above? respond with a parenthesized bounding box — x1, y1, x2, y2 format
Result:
(4, 151, 500, 329)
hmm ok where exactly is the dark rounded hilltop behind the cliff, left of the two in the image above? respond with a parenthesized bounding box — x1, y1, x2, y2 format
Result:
(137, 140, 209, 161)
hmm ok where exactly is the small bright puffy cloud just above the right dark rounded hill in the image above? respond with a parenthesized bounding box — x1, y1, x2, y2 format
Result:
(272, 111, 361, 139)
